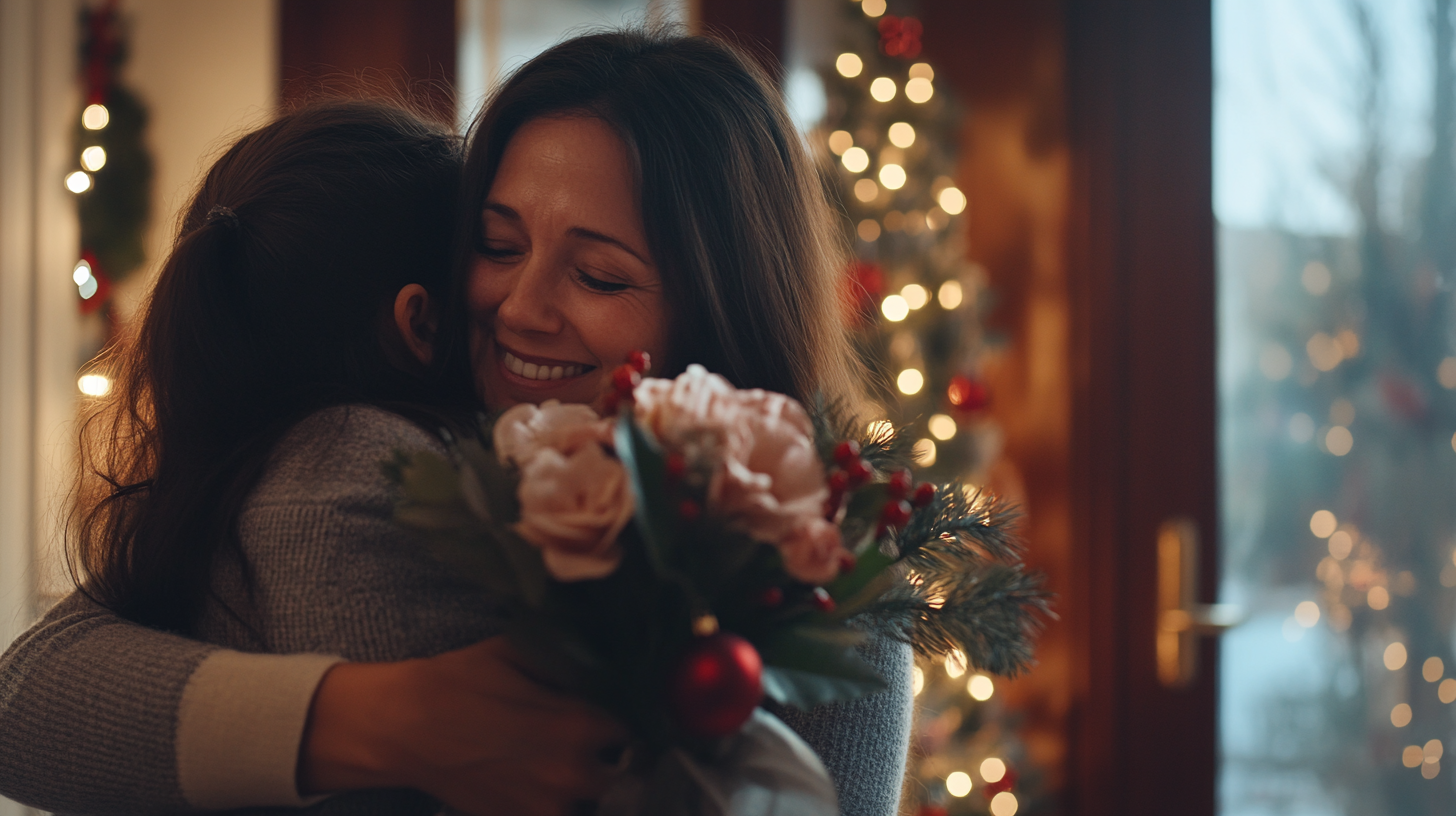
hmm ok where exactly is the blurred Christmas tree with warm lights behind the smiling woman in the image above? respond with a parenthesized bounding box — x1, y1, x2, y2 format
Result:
(812, 0, 1040, 816)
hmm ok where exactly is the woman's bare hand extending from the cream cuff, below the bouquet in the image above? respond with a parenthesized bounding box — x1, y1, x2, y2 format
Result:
(298, 637, 628, 816)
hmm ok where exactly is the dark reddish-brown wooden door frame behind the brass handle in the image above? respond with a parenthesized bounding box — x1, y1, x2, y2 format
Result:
(1061, 0, 1217, 816)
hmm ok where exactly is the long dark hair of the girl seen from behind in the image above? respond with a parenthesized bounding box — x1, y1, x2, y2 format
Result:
(68, 102, 473, 631)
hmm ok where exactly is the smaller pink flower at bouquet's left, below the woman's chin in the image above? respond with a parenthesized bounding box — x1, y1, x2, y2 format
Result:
(494, 401, 633, 581)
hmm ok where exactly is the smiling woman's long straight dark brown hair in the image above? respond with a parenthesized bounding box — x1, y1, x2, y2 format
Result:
(450, 31, 862, 408)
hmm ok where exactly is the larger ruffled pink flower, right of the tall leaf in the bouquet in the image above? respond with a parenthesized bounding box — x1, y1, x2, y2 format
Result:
(635, 366, 843, 583)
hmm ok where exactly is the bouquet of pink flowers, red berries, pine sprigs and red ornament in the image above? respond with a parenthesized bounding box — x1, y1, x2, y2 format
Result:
(387, 353, 1047, 816)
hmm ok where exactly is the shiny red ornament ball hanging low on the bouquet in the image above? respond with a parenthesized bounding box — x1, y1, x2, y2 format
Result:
(668, 632, 763, 737)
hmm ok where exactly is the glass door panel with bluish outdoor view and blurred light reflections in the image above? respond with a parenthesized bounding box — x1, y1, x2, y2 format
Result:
(1213, 0, 1456, 816)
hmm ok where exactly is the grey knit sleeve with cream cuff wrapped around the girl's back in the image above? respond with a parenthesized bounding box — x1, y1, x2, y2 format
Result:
(0, 593, 335, 815)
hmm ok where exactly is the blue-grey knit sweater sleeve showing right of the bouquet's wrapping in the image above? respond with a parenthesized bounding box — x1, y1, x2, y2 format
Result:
(775, 638, 914, 816)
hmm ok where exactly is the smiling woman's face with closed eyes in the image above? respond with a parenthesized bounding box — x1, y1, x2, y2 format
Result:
(467, 118, 668, 409)
